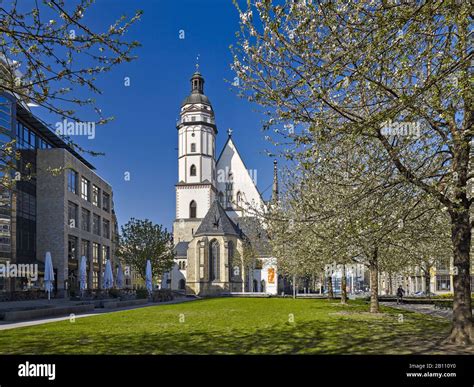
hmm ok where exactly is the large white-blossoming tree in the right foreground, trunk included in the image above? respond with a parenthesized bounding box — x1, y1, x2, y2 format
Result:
(232, 0, 474, 343)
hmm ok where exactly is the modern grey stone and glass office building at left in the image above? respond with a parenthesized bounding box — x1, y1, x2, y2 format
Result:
(0, 94, 117, 296)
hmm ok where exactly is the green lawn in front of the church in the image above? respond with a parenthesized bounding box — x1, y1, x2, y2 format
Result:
(0, 298, 462, 354)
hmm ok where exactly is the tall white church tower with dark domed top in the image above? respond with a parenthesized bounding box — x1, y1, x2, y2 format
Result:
(173, 66, 217, 243)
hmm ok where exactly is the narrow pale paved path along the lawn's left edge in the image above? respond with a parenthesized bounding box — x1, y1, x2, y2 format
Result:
(0, 298, 199, 331)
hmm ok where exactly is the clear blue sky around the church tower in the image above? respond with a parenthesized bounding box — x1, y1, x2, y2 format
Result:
(30, 0, 273, 229)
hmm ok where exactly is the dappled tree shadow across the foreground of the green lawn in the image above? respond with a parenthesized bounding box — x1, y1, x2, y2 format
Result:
(0, 314, 462, 354)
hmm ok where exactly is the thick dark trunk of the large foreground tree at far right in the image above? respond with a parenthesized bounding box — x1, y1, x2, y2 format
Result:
(448, 208, 474, 344)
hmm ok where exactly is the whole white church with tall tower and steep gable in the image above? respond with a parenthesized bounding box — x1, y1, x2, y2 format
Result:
(163, 71, 278, 296)
